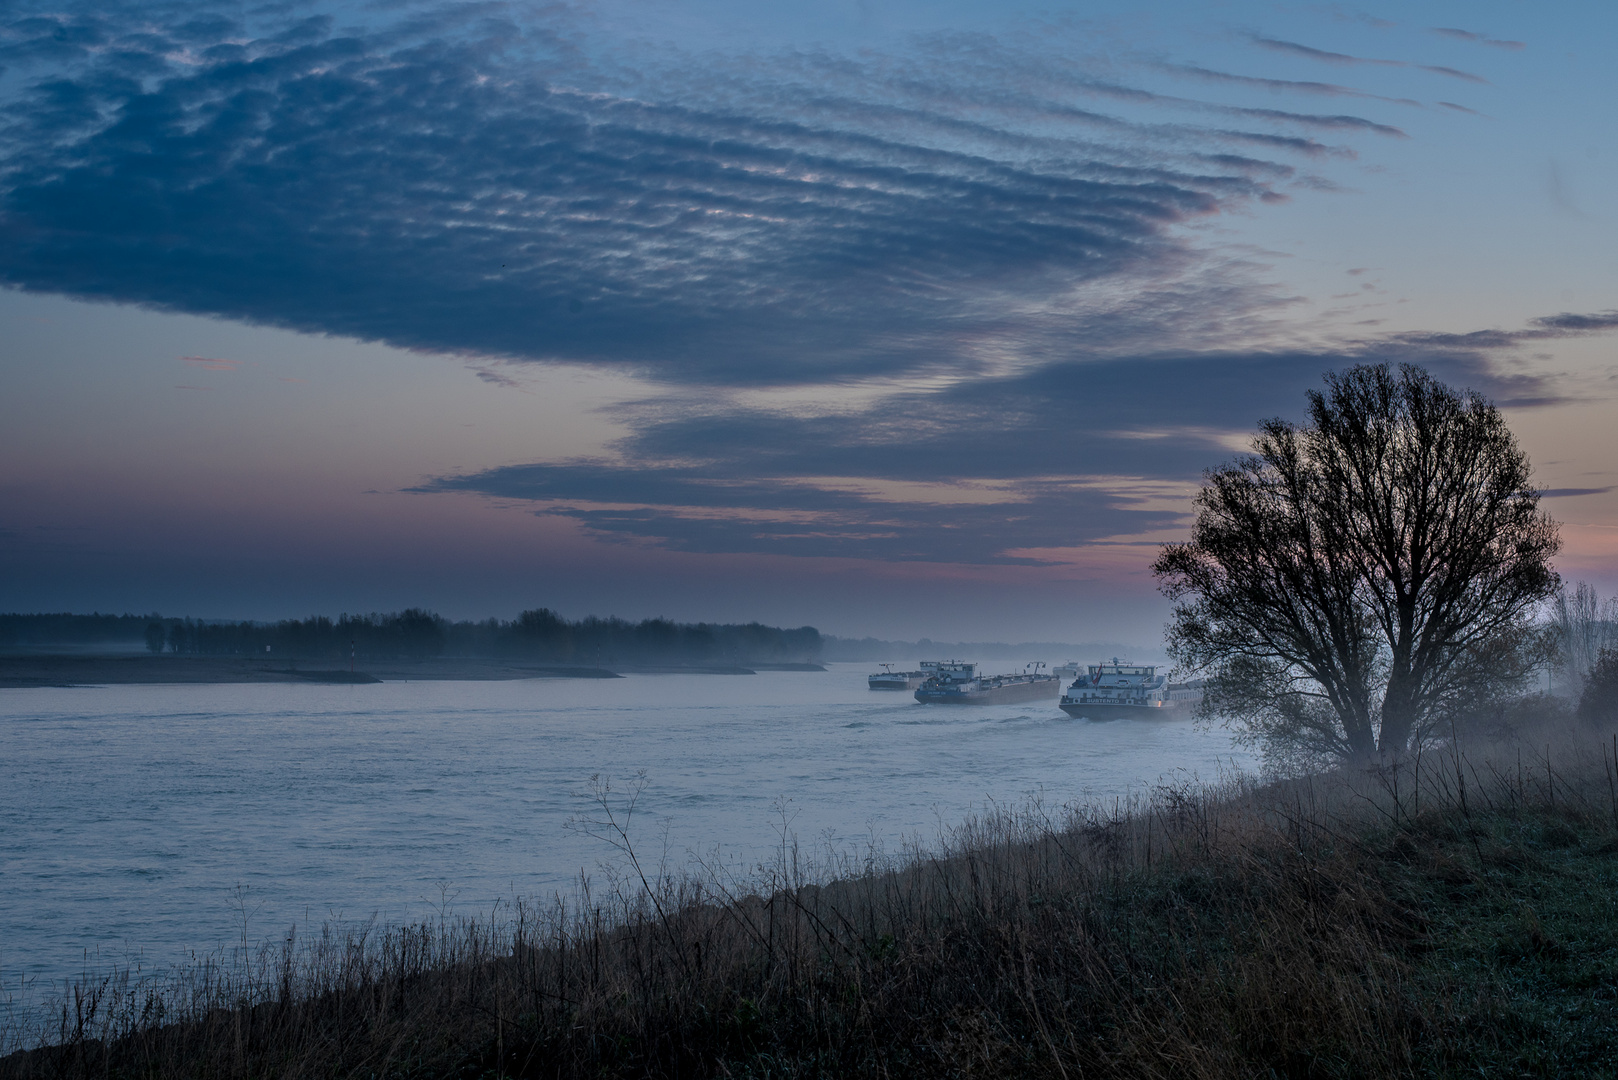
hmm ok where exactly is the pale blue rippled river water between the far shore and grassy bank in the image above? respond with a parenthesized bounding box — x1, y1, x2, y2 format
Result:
(0, 664, 1251, 1002)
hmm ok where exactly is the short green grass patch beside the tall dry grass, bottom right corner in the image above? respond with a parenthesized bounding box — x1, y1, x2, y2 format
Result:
(1383, 780, 1618, 1077)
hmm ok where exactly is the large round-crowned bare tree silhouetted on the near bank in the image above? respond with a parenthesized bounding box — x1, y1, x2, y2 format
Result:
(1152, 364, 1560, 758)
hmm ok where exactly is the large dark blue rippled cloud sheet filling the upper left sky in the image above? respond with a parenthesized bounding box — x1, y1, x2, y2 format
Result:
(0, 5, 1436, 384)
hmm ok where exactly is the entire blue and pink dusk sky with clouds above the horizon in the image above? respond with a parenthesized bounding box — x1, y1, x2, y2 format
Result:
(0, 0, 1618, 644)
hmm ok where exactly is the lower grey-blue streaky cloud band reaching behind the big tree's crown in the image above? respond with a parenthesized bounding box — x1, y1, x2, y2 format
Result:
(414, 313, 1618, 565)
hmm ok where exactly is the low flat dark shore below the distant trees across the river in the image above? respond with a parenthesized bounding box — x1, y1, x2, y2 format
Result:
(0, 654, 618, 688)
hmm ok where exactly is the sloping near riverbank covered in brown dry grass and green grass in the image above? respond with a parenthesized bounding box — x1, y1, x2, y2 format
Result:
(0, 730, 1618, 1080)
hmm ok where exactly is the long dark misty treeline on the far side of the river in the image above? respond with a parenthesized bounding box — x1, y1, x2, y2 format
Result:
(0, 607, 820, 667)
